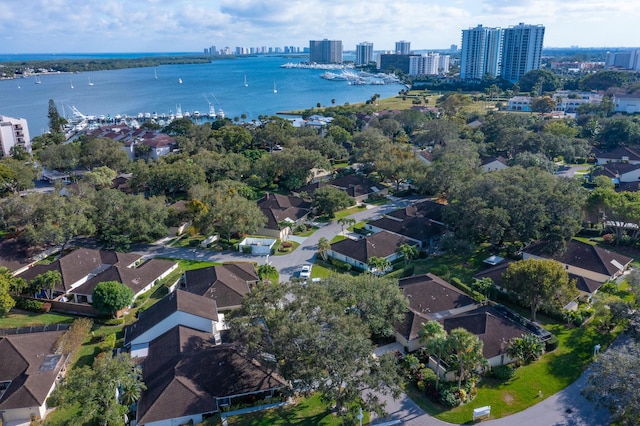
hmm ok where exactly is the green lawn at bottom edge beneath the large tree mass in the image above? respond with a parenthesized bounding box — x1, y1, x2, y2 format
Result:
(227, 395, 369, 426)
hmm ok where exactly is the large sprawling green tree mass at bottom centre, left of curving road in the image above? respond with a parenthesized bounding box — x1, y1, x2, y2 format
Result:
(230, 275, 407, 420)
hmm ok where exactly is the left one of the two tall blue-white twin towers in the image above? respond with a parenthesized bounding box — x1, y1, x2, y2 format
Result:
(460, 25, 502, 80)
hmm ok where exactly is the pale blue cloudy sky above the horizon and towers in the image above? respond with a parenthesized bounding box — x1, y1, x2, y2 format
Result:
(0, 0, 640, 53)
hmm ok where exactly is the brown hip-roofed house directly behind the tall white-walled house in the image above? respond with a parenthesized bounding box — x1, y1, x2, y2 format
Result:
(180, 263, 259, 311)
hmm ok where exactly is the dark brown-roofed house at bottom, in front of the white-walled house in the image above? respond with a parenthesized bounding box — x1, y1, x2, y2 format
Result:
(137, 325, 286, 426)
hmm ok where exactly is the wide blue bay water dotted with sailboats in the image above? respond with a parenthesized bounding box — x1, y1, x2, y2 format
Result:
(0, 55, 400, 137)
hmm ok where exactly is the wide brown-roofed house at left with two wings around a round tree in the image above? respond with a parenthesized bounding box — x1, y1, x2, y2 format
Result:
(19, 248, 178, 303)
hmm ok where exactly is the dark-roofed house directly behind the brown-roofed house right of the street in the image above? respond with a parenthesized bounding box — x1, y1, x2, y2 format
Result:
(364, 200, 446, 251)
